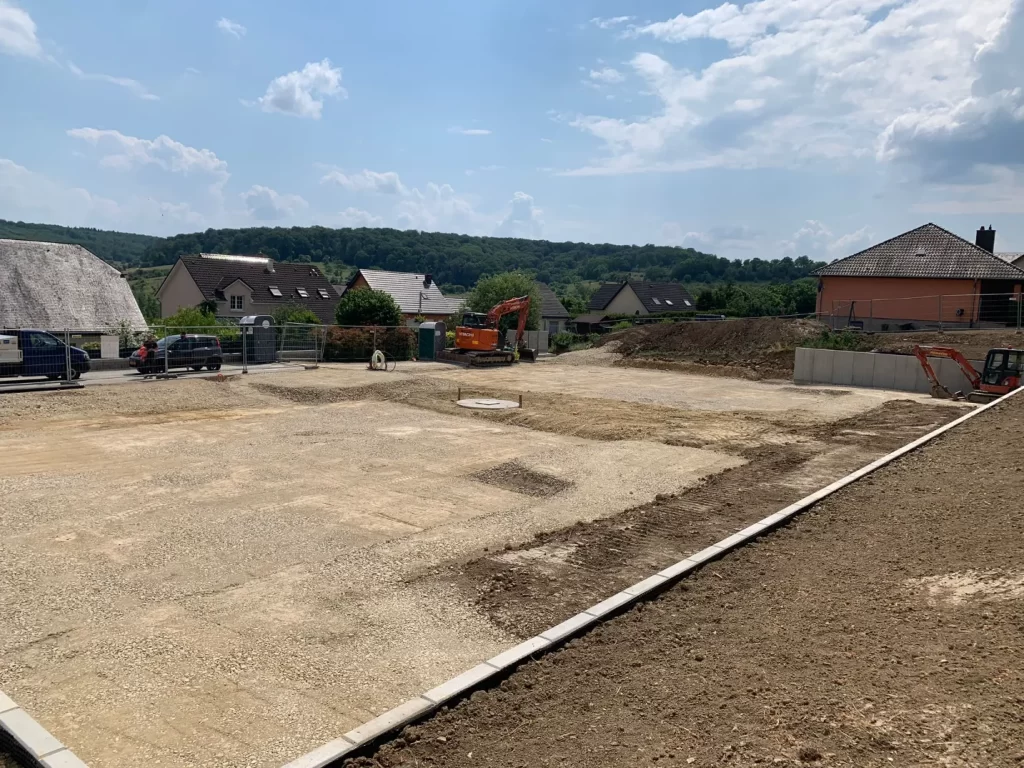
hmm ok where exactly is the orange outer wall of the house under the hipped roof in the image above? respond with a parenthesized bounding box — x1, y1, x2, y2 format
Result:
(818, 276, 980, 331)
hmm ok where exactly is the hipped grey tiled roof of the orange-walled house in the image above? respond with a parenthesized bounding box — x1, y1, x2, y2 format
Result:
(812, 224, 1024, 281)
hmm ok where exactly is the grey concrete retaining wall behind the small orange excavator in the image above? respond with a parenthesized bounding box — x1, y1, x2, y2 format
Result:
(793, 347, 984, 394)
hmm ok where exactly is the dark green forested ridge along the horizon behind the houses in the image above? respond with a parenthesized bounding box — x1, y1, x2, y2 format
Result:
(0, 220, 821, 291)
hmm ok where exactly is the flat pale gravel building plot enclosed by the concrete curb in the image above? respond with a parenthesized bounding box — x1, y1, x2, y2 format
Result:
(0, 362, 963, 768)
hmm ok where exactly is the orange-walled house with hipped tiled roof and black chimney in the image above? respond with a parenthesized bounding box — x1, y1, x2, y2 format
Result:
(813, 223, 1024, 331)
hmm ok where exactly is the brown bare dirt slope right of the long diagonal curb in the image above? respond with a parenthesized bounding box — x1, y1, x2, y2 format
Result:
(347, 398, 1024, 768)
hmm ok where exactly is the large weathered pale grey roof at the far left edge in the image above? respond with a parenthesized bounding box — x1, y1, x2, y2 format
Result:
(0, 240, 145, 331)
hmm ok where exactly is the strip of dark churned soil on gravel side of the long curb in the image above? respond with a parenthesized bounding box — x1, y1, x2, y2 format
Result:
(430, 400, 962, 638)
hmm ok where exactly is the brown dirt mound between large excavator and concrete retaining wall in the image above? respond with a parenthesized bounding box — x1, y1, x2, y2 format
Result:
(602, 317, 825, 378)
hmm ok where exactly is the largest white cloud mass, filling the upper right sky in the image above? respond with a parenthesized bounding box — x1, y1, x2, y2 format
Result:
(563, 0, 1024, 180)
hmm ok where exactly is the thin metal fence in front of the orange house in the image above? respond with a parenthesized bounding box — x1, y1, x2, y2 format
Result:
(818, 293, 1024, 333)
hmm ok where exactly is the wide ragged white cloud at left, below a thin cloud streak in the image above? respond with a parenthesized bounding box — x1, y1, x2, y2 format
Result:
(68, 128, 229, 184)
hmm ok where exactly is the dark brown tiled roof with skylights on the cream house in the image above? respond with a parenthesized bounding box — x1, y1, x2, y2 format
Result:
(174, 253, 338, 323)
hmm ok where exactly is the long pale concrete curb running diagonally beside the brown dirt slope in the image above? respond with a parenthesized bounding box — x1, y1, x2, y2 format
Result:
(284, 387, 1024, 768)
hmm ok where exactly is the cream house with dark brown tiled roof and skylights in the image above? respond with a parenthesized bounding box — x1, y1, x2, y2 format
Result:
(157, 253, 340, 323)
